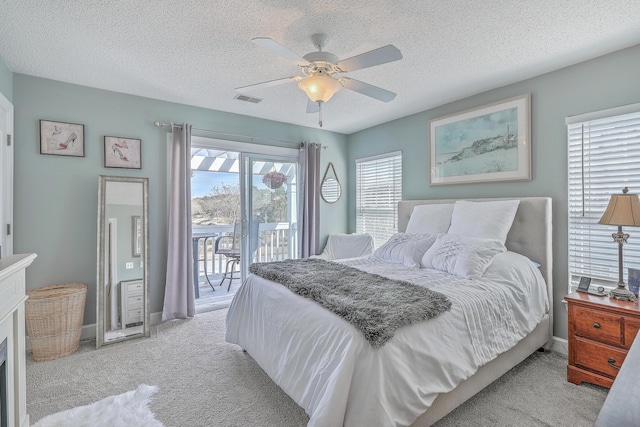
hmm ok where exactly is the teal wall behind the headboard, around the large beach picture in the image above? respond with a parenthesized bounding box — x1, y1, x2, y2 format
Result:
(348, 45, 640, 338)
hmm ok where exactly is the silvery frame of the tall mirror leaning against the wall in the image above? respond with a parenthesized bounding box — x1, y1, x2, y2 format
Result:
(96, 175, 151, 348)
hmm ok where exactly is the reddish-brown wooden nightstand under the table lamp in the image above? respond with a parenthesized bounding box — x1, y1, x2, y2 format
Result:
(564, 292, 640, 388)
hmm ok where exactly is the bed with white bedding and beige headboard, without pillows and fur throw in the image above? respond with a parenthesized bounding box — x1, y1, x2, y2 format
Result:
(226, 197, 553, 426)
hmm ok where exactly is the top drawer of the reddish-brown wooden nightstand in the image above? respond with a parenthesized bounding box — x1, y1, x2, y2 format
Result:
(573, 306, 620, 345)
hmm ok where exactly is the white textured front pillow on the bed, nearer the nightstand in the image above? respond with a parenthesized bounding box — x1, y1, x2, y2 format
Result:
(421, 234, 507, 279)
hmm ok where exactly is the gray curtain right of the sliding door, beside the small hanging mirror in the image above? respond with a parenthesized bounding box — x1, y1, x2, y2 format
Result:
(298, 142, 322, 258)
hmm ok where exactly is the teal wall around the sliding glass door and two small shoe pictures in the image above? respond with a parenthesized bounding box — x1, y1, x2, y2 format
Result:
(12, 74, 348, 324)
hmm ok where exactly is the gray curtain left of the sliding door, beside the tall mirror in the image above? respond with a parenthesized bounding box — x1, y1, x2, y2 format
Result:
(162, 123, 196, 322)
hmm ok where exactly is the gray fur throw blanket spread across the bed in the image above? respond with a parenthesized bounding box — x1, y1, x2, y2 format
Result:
(249, 258, 451, 348)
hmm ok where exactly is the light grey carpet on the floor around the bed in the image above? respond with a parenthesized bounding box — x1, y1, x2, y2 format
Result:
(27, 310, 607, 427)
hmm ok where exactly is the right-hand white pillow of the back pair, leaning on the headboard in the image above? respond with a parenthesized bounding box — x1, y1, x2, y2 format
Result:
(447, 200, 520, 244)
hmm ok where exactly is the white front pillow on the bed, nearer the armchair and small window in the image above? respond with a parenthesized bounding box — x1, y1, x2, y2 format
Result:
(371, 233, 438, 267)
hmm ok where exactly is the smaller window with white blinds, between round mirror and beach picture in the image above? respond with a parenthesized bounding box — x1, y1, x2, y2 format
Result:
(356, 151, 402, 247)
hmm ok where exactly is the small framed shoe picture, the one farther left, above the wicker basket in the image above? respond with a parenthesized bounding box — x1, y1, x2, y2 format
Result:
(40, 120, 84, 157)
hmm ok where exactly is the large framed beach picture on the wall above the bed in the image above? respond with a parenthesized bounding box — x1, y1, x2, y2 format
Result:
(429, 94, 531, 185)
